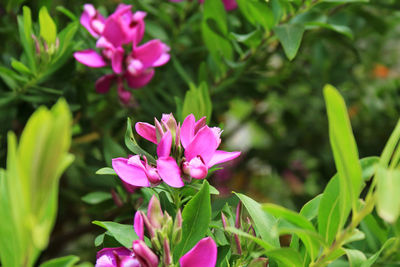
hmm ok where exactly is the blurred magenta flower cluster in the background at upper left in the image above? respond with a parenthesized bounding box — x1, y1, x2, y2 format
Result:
(74, 4, 170, 105)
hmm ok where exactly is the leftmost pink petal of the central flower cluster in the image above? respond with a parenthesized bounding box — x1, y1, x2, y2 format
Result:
(112, 158, 150, 186)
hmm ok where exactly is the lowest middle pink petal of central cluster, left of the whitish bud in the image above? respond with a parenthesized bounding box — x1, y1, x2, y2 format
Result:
(157, 157, 185, 188)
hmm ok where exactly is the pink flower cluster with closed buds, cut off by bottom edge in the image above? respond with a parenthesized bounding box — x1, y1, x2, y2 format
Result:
(96, 196, 217, 267)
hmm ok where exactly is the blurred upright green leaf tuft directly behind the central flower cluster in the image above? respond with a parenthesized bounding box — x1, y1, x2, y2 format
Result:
(182, 82, 212, 122)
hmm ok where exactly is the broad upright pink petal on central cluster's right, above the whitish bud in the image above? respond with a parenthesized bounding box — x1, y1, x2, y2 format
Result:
(185, 126, 218, 166)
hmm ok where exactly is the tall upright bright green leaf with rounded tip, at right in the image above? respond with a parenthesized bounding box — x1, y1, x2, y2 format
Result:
(324, 85, 362, 217)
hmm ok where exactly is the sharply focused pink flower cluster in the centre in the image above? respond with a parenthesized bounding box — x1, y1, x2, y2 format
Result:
(112, 114, 240, 187)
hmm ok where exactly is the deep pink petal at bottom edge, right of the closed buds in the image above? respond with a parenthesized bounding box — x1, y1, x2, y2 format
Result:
(179, 237, 217, 267)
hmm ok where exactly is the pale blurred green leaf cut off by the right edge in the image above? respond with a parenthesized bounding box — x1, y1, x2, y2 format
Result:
(376, 166, 400, 223)
